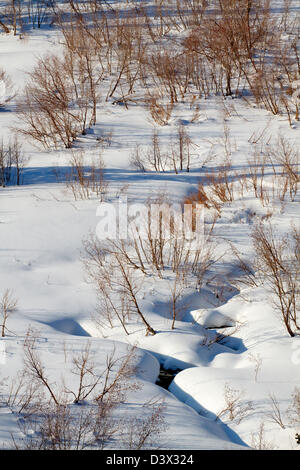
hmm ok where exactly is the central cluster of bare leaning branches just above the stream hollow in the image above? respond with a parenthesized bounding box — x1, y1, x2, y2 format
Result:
(83, 197, 216, 335)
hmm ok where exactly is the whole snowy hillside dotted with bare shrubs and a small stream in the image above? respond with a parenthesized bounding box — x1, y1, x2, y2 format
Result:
(0, 0, 300, 450)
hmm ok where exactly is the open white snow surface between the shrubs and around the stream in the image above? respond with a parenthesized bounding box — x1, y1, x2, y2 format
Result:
(0, 0, 300, 449)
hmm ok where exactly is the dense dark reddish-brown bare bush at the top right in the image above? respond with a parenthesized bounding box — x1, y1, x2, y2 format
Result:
(187, 0, 271, 95)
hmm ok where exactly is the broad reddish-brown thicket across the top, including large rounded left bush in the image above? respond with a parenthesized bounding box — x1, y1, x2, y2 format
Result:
(15, 0, 300, 147)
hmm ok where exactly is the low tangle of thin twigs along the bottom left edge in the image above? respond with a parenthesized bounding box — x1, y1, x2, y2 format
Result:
(13, 392, 166, 450)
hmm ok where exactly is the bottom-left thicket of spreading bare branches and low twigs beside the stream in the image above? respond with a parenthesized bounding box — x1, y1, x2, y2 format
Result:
(0, 329, 165, 450)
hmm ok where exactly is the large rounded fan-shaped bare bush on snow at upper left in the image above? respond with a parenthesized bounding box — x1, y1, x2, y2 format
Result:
(18, 50, 95, 148)
